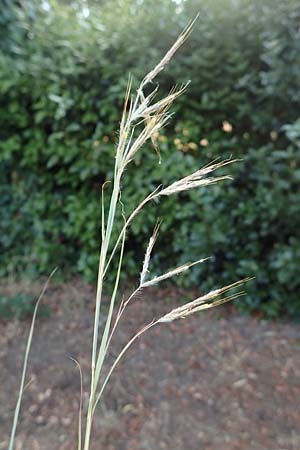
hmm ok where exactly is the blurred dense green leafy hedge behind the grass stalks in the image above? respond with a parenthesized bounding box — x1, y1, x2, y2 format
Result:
(0, 0, 300, 315)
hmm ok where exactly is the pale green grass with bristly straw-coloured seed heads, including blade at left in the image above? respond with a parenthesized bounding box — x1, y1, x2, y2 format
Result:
(9, 22, 250, 450)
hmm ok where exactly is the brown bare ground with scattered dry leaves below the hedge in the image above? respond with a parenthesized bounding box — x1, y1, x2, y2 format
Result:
(0, 281, 300, 450)
